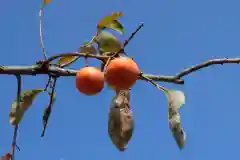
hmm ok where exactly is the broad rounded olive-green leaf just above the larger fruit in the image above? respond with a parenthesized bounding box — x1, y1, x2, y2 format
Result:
(95, 31, 122, 52)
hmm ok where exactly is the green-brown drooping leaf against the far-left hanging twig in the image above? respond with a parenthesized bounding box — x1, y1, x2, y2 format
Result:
(10, 89, 44, 125)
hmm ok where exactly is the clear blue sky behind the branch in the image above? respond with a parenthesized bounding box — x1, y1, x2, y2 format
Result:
(0, 0, 240, 160)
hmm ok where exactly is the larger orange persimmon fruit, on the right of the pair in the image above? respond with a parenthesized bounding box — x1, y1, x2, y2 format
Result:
(105, 57, 140, 91)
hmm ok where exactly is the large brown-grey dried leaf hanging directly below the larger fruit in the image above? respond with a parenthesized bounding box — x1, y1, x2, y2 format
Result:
(108, 90, 134, 151)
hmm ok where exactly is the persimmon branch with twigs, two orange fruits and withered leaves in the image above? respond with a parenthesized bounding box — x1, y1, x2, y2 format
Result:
(0, 0, 240, 160)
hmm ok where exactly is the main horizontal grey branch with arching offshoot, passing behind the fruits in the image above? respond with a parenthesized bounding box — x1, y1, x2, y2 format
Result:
(0, 56, 240, 84)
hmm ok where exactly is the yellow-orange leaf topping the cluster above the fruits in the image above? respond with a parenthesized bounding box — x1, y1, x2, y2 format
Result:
(97, 12, 123, 29)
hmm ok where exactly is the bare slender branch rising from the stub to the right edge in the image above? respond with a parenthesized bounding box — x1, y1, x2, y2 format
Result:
(175, 58, 240, 79)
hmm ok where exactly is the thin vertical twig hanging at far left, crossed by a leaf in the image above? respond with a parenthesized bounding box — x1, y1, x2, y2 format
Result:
(12, 74, 22, 160)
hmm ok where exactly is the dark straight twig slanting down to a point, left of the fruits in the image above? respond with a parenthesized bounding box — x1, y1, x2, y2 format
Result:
(41, 77, 57, 137)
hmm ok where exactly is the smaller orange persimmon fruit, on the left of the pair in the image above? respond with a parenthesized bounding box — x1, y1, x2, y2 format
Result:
(76, 67, 104, 96)
